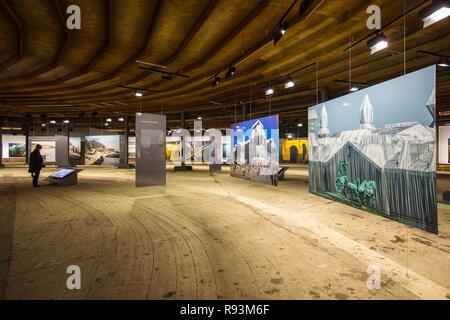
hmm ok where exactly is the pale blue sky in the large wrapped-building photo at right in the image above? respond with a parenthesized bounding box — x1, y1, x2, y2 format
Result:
(312, 66, 436, 134)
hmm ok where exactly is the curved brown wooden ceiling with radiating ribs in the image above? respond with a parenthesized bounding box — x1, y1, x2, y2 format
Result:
(0, 0, 450, 127)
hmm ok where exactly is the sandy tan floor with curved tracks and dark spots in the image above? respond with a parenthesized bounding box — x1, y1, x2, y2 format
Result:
(0, 167, 450, 299)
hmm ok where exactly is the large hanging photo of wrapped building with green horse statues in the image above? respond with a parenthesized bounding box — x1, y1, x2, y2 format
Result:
(308, 66, 438, 233)
